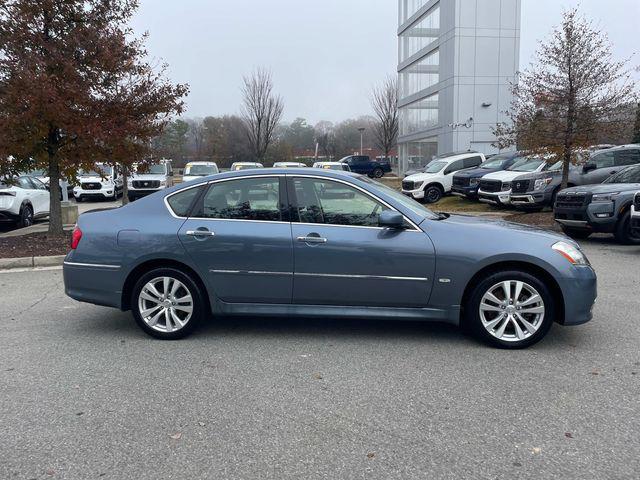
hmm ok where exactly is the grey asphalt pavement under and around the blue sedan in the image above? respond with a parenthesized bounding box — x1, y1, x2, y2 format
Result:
(0, 238, 640, 479)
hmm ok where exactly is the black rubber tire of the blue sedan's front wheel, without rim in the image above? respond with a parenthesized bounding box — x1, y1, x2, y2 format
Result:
(463, 270, 556, 349)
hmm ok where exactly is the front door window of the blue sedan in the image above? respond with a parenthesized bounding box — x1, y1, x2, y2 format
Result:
(293, 178, 386, 227)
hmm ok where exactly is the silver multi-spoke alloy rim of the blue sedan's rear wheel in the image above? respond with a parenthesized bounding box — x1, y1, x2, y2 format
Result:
(138, 277, 193, 333)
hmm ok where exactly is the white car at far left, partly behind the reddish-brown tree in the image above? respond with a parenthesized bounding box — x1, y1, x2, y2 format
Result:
(0, 176, 49, 227)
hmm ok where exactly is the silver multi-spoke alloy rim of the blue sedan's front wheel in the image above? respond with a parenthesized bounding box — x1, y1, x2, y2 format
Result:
(479, 280, 545, 342)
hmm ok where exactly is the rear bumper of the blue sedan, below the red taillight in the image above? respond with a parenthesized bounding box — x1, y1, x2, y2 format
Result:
(62, 254, 124, 308)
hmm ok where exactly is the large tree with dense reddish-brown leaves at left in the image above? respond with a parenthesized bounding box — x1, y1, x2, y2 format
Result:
(0, 0, 187, 234)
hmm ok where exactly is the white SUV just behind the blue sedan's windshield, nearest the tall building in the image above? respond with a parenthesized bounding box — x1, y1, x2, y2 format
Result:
(402, 152, 485, 203)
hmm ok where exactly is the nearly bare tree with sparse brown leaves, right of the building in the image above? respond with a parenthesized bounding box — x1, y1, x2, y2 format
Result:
(495, 9, 636, 187)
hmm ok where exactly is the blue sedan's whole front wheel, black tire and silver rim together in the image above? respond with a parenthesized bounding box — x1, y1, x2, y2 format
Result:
(463, 270, 556, 349)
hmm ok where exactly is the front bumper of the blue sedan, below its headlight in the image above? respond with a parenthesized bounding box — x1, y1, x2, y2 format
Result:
(558, 266, 598, 326)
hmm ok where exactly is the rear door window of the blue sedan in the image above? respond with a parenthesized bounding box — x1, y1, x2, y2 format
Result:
(199, 177, 282, 221)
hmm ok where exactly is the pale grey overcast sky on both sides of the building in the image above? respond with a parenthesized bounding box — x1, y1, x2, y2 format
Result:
(133, 0, 640, 123)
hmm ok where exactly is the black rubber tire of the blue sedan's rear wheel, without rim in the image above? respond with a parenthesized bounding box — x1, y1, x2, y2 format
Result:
(130, 268, 207, 340)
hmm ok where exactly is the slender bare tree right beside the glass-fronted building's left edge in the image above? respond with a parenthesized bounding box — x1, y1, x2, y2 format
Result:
(371, 77, 399, 158)
